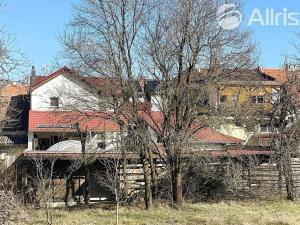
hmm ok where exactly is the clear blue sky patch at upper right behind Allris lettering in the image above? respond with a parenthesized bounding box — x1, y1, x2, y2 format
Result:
(243, 0, 300, 67)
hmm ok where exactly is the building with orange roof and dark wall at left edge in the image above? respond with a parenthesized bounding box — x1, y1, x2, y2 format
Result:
(0, 81, 29, 167)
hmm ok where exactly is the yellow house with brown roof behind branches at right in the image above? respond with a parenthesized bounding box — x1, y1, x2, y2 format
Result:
(217, 67, 286, 144)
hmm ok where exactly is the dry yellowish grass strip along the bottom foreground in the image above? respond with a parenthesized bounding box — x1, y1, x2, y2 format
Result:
(22, 201, 300, 225)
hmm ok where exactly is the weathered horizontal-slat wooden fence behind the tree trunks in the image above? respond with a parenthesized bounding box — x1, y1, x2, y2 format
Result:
(120, 158, 300, 198)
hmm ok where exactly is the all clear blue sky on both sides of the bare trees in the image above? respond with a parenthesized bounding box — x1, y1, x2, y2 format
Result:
(0, 0, 300, 76)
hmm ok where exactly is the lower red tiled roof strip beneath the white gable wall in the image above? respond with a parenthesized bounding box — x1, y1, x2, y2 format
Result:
(28, 111, 119, 132)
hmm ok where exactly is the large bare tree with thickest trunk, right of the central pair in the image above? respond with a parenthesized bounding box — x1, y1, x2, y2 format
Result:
(141, 1, 255, 206)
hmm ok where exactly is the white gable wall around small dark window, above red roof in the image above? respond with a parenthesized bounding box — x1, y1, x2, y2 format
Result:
(31, 75, 99, 111)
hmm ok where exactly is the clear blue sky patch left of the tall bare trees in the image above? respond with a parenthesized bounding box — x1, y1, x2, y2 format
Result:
(0, 0, 74, 75)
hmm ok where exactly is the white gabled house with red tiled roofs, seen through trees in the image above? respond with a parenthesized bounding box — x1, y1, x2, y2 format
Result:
(28, 67, 251, 154)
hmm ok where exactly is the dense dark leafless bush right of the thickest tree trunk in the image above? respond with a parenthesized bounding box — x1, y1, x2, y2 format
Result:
(183, 158, 242, 201)
